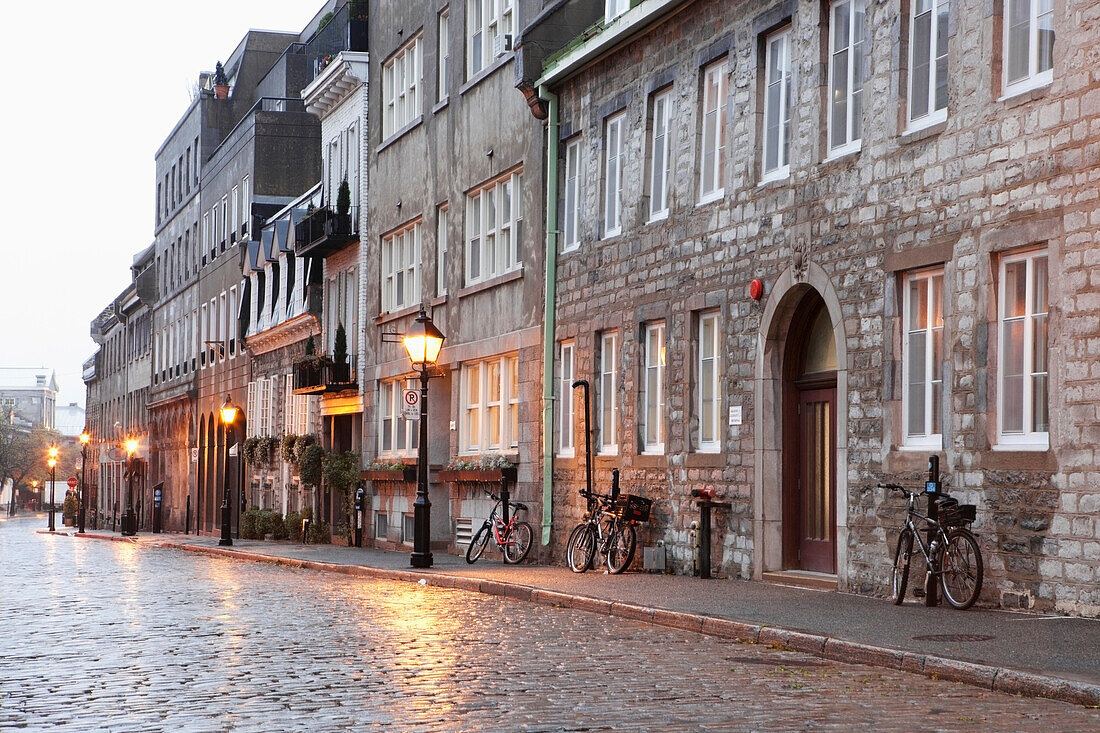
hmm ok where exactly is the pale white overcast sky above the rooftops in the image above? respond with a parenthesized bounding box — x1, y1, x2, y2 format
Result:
(0, 0, 325, 406)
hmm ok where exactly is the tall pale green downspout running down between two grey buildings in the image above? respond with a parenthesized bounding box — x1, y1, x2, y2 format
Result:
(539, 86, 558, 545)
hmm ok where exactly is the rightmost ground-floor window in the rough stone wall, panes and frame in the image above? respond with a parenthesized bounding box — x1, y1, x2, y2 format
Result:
(998, 251, 1048, 448)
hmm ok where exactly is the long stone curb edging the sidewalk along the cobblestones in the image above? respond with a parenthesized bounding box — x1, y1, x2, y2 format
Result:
(157, 533, 1100, 707)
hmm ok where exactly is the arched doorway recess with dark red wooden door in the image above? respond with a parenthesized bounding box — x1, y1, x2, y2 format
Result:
(782, 288, 837, 573)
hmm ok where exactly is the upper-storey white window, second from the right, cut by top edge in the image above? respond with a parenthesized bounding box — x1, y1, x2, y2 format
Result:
(909, 0, 950, 127)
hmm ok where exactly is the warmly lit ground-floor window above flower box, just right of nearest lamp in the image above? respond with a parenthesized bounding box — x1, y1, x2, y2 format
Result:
(460, 355, 519, 453)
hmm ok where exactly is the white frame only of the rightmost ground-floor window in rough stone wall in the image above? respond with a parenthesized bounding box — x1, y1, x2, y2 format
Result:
(994, 249, 1051, 450)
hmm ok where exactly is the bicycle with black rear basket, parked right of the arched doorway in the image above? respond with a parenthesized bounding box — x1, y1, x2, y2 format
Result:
(879, 483, 983, 610)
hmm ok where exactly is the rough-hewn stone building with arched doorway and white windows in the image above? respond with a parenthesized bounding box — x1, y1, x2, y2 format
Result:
(521, 0, 1100, 615)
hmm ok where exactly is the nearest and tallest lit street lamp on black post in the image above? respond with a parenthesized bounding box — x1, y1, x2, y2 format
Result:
(403, 308, 446, 568)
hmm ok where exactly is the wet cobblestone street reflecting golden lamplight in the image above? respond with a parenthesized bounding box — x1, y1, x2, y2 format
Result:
(0, 518, 1100, 731)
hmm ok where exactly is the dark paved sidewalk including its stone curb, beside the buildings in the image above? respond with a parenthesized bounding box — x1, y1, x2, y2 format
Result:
(57, 527, 1100, 705)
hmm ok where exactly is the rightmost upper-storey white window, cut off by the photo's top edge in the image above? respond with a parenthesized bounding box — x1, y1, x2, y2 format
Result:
(1004, 0, 1054, 94)
